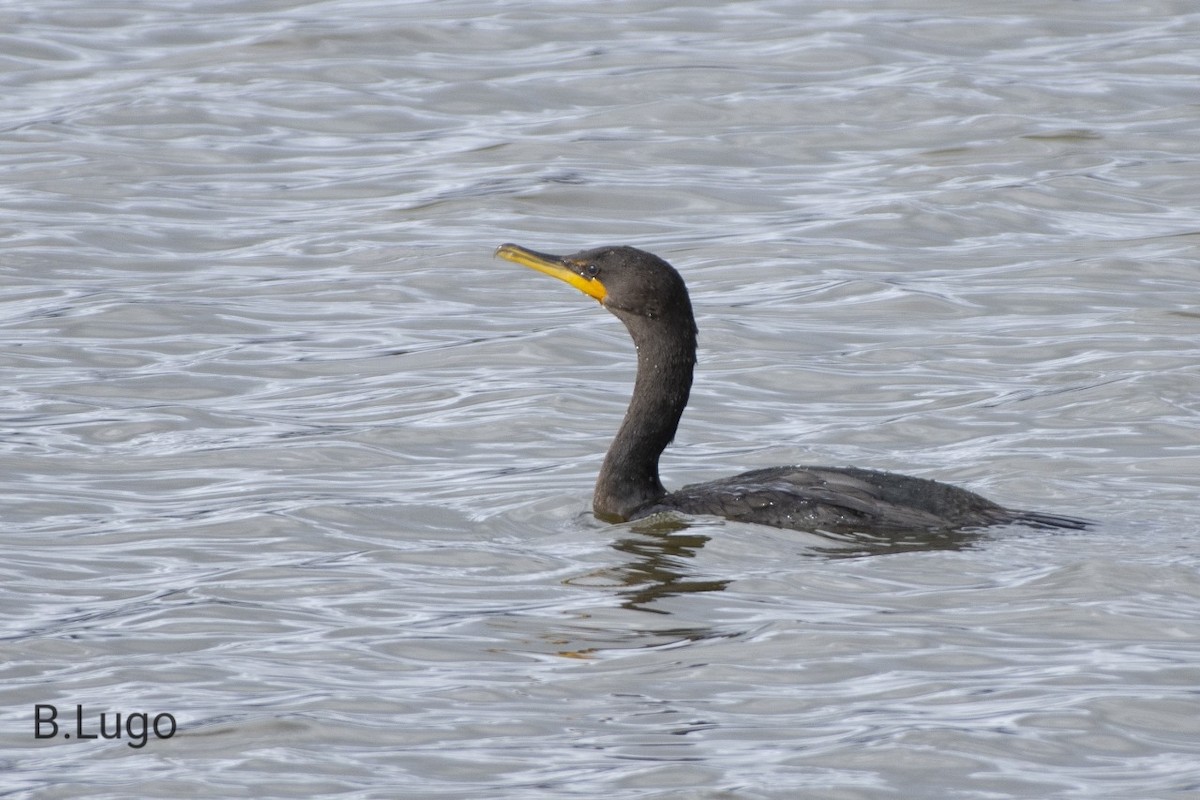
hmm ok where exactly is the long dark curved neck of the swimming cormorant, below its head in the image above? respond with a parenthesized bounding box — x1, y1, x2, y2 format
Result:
(592, 308, 696, 519)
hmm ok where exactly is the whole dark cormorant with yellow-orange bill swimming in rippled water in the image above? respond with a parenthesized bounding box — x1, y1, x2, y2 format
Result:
(496, 245, 1085, 534)
